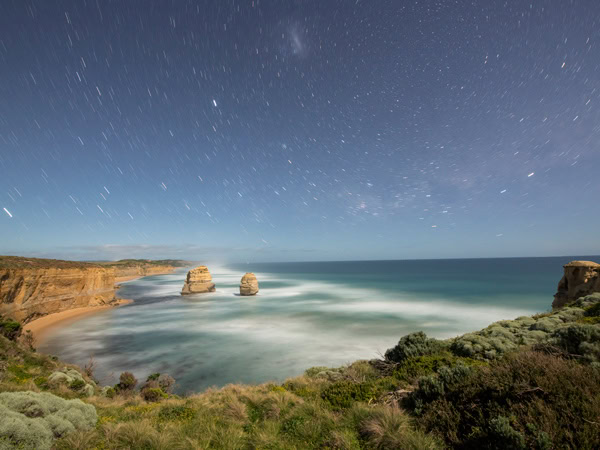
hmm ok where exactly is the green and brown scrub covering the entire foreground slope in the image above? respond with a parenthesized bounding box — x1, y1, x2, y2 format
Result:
(0, 295, 600, 449)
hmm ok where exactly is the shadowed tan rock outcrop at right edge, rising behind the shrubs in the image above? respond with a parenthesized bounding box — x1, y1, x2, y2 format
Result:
(552, 261, 600, 308)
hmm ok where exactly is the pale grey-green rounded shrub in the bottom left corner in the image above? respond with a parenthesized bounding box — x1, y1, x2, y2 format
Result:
(0, 391, 98, 449)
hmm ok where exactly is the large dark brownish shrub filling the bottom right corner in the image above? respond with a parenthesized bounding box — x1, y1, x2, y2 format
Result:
(413, 351, 600, 449)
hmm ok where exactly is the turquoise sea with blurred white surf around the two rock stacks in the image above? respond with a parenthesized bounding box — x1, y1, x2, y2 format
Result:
(39, 257, 589, 393)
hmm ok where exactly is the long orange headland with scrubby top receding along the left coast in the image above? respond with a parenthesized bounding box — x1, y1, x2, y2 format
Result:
(0, 256, 186, 323)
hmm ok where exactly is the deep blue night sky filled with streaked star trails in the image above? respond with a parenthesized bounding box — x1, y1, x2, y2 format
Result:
(0, 0, 600, 261)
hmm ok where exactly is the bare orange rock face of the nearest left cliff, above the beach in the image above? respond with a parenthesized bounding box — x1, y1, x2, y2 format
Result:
(0, 266, 116, 323)
